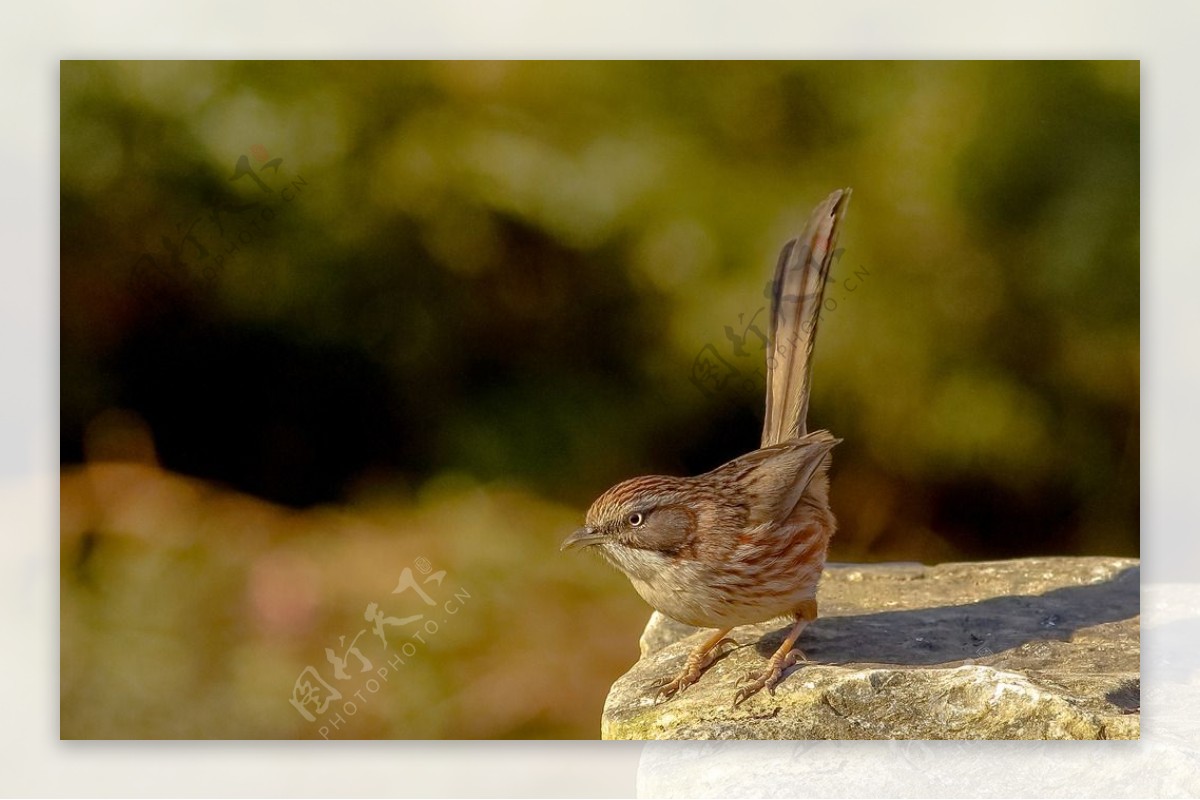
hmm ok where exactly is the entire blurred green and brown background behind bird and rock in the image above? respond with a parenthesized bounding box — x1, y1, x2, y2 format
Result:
(60, 61, 1139, 739)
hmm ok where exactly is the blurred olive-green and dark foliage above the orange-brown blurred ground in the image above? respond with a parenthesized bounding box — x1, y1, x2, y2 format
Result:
(61, 61, 1140, 735)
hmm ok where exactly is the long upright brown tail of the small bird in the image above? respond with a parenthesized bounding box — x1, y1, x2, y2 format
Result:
(762, 188, 850, 447)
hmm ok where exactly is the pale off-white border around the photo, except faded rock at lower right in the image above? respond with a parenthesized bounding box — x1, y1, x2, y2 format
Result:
(0, 0, 1200, 796)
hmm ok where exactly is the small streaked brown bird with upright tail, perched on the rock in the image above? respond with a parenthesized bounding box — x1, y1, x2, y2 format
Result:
(562, 188, 850, 705)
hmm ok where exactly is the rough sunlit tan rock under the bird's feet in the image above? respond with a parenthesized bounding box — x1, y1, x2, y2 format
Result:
(601, 558, 1140, 739)
